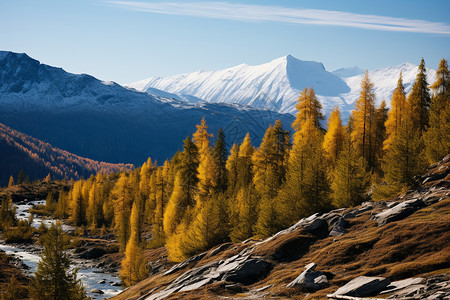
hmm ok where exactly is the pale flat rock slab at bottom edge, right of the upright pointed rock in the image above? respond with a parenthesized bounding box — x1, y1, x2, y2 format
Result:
(333, 276, 391, 297)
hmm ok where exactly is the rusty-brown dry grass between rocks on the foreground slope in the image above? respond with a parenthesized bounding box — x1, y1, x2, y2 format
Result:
(115, 186, 450, 299)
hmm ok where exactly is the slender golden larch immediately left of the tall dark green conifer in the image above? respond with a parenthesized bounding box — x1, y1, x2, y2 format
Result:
(383, 72, 406, 150)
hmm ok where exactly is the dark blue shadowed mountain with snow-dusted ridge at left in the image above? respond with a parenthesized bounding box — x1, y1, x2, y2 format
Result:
(0, 52, 293, 165)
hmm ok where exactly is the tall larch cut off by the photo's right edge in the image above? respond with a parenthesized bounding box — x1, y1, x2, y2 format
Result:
(424, 59, 450, 163)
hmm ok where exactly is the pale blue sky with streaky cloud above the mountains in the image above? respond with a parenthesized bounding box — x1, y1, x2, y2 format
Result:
(0, 0, 450, 84)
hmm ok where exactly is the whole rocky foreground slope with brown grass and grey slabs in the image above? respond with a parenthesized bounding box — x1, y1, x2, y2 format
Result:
(114, 155, 450, 299)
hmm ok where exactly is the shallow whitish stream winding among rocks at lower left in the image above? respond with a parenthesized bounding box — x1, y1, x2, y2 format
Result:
(0, 200, 122, 299)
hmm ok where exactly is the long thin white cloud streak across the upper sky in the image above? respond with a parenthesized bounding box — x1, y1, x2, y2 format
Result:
(106, 1, 450, 35)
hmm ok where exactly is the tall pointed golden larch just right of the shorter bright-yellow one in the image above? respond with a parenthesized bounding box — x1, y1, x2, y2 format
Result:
(352, 71, 376, 171)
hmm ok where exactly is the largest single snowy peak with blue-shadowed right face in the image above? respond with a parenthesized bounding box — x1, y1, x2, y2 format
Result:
(129, 55, 350, 113)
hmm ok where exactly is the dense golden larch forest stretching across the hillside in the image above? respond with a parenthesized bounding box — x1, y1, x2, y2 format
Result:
(5, 59, 450, 285)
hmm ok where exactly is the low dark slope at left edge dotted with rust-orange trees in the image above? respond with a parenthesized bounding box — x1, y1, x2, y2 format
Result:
(0, 123, 133, 186)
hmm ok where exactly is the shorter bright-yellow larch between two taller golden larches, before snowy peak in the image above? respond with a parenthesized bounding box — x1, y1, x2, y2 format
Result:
(323, 106, 345, 166)
